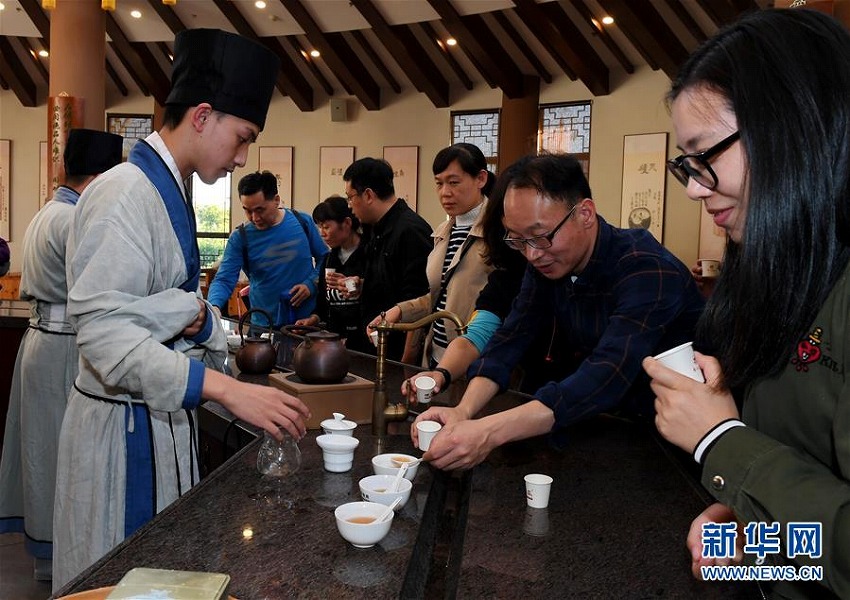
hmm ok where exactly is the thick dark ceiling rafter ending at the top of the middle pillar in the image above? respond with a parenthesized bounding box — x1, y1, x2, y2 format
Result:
(428, 0, 524, 98)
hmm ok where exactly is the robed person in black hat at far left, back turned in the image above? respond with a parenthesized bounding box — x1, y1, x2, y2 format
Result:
(0, 129, 123, 579)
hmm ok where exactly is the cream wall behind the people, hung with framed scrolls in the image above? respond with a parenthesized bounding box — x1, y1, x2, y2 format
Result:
(0, 67, 700, 270)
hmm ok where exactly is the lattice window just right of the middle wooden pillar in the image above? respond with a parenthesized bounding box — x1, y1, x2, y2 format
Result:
(537, 101, 590, 177)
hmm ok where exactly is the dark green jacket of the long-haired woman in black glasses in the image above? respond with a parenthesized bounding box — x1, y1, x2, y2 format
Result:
(702, 270, 850, 599)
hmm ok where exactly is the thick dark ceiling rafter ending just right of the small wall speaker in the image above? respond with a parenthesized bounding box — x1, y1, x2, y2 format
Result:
(280, 0, 381, 110)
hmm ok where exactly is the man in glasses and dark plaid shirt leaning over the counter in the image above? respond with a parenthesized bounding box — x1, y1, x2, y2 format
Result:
(411, 154, 711, 469)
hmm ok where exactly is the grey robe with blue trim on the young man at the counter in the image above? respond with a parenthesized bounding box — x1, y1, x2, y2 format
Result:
(53, 133, 227, 590)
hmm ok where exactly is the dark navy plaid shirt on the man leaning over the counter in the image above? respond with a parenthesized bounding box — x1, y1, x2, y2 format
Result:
(468, 217, 704, 428)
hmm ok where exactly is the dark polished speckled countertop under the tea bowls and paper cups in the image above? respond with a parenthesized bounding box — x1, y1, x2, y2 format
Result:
(53, 340, 759, 600)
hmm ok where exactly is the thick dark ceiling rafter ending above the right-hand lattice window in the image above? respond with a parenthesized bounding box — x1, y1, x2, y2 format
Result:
(506, 0, 611, 96)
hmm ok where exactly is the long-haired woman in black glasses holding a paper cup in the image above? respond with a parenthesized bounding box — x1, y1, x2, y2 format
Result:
(644, 9, 850, 598)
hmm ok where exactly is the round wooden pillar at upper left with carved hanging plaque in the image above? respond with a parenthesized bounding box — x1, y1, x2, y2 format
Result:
(47, 0, 106, 195)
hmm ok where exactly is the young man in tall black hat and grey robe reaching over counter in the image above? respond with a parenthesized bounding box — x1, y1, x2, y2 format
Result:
(53, 29, 309, 591)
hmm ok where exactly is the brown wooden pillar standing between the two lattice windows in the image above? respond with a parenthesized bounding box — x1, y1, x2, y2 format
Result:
(498, 76, 540, 173)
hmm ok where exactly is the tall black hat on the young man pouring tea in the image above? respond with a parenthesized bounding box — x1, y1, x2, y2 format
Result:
(165, 29, 280, 130)
